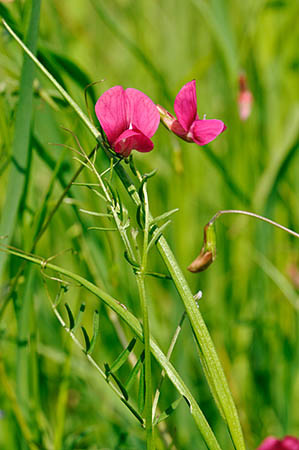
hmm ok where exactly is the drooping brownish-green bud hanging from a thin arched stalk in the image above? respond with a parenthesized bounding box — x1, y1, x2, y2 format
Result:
(188, 223, 216, 273)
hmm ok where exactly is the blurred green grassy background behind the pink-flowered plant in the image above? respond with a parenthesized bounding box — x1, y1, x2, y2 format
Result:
(0, 0, 299, 450)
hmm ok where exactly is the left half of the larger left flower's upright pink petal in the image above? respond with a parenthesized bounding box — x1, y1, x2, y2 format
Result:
(95, 86, 129, 144)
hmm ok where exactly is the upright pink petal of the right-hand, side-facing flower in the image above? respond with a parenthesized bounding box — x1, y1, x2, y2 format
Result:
(174, 80, 197, 131)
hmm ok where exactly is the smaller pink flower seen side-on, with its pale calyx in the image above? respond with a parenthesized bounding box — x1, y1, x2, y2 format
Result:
(157, 80, 226, 145)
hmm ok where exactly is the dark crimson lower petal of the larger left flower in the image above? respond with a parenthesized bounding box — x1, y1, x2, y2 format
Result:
(112, 129, 154, 157)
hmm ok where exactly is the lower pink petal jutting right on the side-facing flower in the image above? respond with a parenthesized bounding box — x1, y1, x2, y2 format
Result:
(190, 119, 226, 145)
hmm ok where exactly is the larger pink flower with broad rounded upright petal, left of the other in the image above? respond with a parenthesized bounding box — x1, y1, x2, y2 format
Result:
(95, 86, 160, 157)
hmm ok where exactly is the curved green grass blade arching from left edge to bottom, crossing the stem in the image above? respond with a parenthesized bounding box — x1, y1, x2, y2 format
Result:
(3, 248, 221, 450)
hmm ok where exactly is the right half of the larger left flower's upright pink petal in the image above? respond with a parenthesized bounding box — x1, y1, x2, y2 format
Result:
(125, 88, 160, 138)
